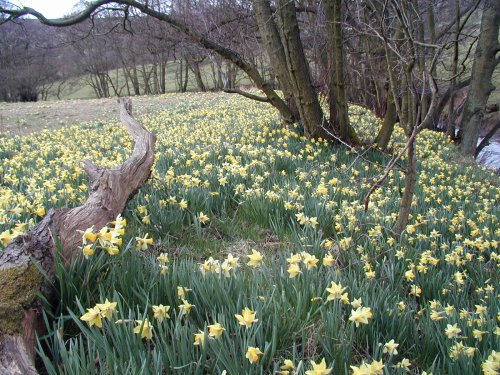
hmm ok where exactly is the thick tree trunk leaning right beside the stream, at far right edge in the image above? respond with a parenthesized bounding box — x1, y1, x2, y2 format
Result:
(460, 0, 500, 156)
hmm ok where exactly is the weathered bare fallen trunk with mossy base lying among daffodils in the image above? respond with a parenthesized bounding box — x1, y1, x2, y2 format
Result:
(0, 100, 156, 374)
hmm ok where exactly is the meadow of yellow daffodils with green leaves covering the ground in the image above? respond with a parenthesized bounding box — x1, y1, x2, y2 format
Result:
(0, 93, 500, 374)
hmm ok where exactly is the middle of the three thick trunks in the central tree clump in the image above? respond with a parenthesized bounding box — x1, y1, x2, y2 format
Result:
(278, 0, 329, 139)
